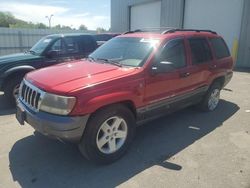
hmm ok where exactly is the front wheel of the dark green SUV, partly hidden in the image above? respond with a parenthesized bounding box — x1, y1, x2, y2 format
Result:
(4, 76, 23, 105)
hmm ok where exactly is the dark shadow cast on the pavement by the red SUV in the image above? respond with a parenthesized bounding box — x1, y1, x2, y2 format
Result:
(9, 100, 239, 188)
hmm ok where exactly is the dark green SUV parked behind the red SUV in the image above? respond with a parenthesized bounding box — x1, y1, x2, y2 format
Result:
(0, 34, 97, 104)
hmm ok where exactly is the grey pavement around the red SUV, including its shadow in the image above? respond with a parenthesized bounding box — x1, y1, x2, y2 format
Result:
(0, 72, 250, 188)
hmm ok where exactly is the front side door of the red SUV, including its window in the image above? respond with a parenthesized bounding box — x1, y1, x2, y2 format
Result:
(145, 38, 194, 109)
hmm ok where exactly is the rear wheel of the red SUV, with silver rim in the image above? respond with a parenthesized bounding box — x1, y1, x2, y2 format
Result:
(198, 82, 221, 112)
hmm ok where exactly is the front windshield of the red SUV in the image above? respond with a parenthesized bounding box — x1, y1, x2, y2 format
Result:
(90, 37, 159, 67)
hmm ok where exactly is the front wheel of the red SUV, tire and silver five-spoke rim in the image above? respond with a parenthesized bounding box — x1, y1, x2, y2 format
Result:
(78, 104, 135, 164)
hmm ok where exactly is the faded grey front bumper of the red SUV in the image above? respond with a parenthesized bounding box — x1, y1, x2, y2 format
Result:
(17, 100, 89, 143)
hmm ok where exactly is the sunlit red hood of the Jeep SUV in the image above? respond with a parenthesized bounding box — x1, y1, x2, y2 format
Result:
(25, 60, 136, 94)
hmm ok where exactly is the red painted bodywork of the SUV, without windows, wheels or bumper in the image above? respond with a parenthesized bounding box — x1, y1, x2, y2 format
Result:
(26, 32, 233, 115)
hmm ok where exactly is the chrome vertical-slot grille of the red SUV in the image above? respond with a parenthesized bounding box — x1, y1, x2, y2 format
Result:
(19, 80, 44, 111)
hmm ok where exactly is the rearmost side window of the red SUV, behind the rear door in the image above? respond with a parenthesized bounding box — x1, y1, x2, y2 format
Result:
(210, 38, 230, 59)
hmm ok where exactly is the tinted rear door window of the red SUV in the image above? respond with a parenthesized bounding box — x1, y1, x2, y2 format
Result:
(188, 38, 212, 64)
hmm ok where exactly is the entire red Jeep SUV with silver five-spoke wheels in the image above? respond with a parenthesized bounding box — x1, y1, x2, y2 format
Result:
(16, 29, 234, 163)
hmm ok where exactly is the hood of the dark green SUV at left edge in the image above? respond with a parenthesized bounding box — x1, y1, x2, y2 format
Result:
(0, 53, 40, 64)
